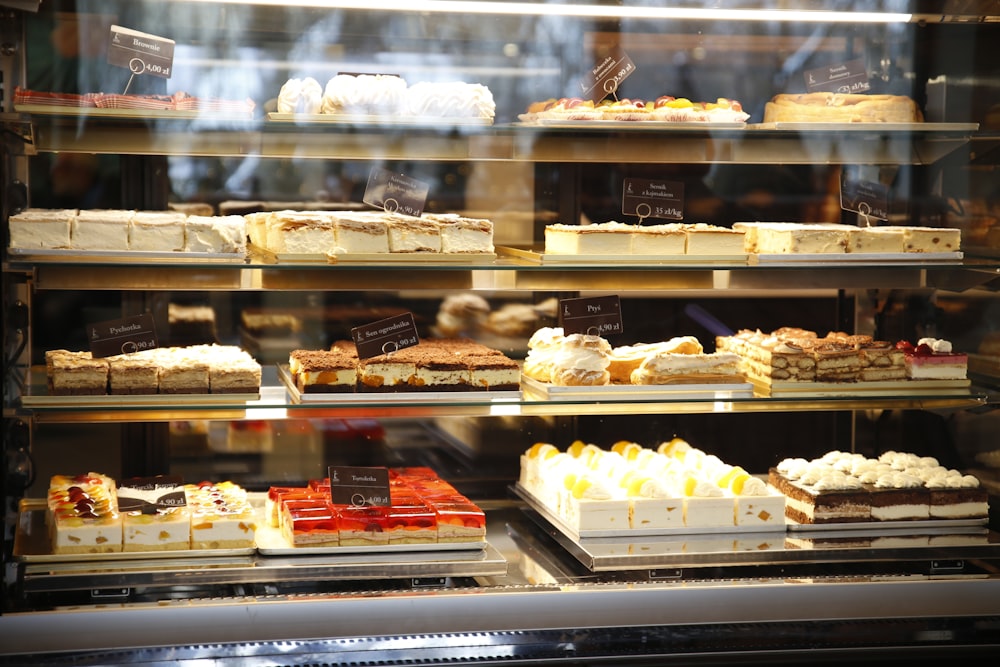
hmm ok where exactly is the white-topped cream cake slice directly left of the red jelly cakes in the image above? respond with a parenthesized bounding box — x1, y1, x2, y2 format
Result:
(184, 482, 257, 549)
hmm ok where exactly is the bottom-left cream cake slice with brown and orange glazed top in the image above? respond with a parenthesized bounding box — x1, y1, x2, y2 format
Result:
(46, 473, 122, 554)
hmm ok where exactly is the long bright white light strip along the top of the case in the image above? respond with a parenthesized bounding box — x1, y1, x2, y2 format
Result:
(188, 0, 913, 23)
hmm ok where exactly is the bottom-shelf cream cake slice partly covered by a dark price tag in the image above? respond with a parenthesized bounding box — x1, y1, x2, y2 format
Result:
(118, 476, 191, 551)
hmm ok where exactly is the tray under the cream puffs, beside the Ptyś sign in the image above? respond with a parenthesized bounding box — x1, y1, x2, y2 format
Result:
(521, 375, 753, 401)
